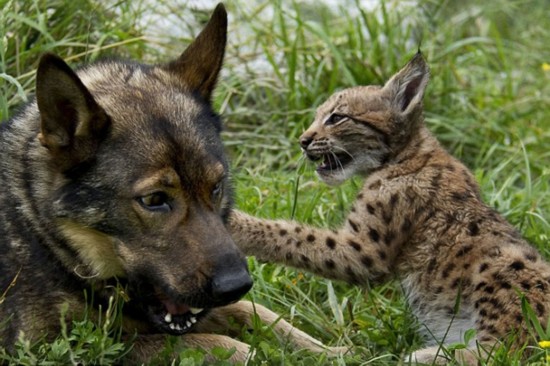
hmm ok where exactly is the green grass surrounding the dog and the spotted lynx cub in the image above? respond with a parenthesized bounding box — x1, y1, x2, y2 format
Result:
(0, 0, 550, 365)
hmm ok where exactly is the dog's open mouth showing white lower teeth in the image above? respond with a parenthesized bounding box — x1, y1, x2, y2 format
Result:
(147, 289, 208, 335)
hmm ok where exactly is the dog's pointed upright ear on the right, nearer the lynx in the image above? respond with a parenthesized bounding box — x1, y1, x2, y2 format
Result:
(165, 3, 227, 101)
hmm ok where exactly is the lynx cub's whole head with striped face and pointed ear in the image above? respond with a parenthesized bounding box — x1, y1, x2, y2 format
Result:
(300, 56, 429, 185)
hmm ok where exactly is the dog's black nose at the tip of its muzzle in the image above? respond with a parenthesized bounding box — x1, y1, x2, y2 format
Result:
(212, 264, 252, 304)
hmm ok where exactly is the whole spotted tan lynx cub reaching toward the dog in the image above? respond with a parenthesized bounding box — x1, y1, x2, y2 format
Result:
(230, 54, 550, 364)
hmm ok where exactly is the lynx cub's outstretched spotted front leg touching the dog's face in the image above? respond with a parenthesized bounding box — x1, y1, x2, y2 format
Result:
(230, 211, 396, 286)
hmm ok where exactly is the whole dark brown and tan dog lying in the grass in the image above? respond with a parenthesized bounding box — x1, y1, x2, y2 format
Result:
(0, 4, 342, 362)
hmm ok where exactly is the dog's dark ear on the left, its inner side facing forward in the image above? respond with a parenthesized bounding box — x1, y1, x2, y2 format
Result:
(36, 54, 110, 170)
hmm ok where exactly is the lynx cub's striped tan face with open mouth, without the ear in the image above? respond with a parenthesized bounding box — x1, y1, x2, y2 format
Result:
(300, 86, 389, 185)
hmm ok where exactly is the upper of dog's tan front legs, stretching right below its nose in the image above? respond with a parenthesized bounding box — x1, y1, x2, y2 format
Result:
(198, 301, 349, 356)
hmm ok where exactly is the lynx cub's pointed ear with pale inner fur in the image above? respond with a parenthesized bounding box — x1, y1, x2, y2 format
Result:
(384, 52, 430, 114)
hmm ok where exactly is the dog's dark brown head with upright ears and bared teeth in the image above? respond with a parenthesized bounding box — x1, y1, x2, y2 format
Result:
(32, 5, 252, 334)
